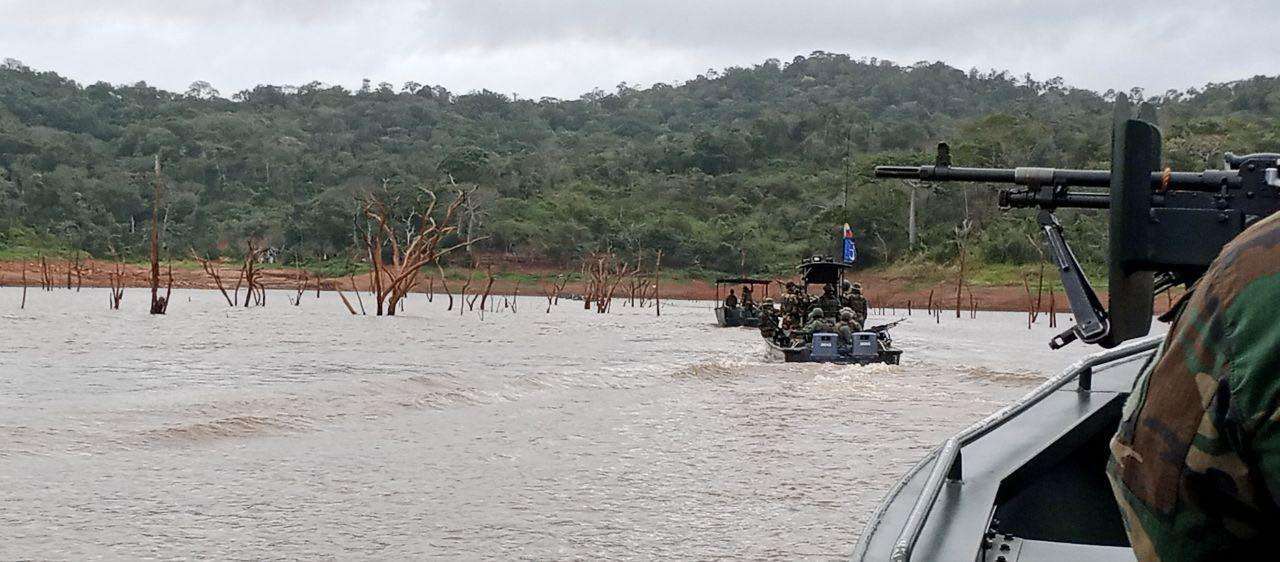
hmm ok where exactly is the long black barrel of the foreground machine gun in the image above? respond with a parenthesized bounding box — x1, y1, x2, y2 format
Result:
(876, 165, 1239, 193)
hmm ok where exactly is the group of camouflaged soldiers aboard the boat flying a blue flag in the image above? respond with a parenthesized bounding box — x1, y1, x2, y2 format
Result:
(760, 280, 869, 347)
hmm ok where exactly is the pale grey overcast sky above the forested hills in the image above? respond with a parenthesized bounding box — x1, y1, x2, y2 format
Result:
(0, 0, 1280, 97)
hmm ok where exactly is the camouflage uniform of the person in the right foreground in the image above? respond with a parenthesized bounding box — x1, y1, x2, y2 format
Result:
(1107, 209, 1280, 562)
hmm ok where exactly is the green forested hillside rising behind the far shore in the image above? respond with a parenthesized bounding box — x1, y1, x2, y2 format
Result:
(0, 52, 1280, 271)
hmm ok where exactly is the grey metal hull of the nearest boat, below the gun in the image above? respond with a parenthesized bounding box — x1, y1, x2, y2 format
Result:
(854, 342, 1155, 562)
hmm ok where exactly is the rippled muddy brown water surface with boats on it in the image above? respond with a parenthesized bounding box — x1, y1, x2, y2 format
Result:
(0, 288, 1087, 559)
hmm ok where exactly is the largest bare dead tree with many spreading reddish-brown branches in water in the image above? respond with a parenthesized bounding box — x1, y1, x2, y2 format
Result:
(364, 188, 483, 316)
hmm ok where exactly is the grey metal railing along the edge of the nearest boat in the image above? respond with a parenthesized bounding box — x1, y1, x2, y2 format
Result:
(891, 335, 1162, 562)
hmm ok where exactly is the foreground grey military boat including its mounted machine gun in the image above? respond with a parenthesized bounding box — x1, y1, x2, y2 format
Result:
(854, 96, 1280, 562)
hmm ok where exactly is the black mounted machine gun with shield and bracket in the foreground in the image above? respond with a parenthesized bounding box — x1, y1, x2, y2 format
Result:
(876, 97, 1280, 349)
